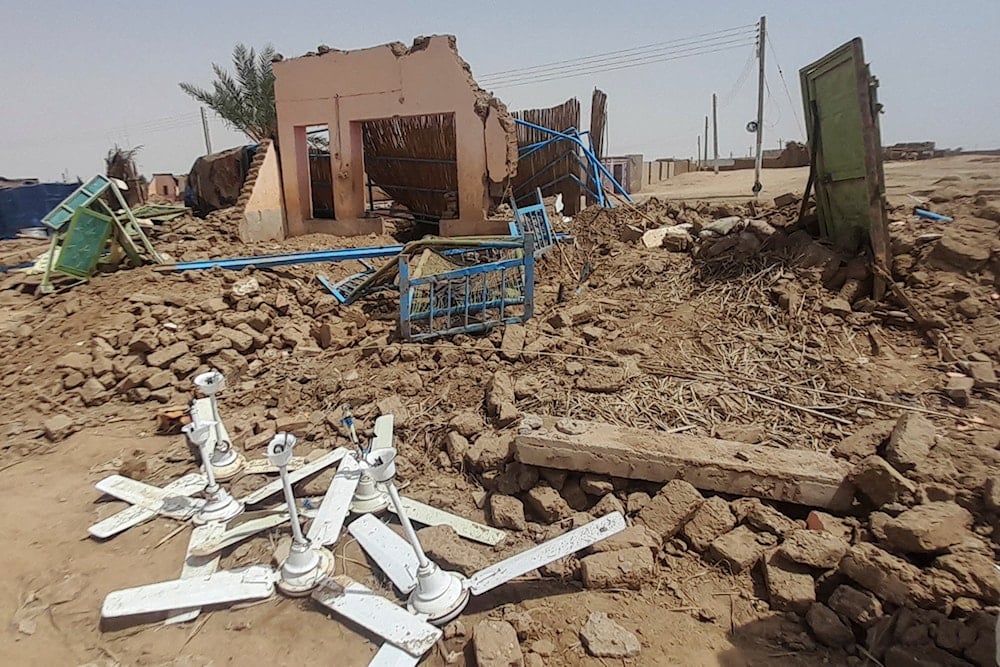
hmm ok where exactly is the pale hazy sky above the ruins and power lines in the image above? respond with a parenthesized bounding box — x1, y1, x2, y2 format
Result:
(0, 0, 1000, 180)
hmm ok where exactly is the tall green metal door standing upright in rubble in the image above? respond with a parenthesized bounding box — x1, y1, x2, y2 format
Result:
(799, 37, 889, 282)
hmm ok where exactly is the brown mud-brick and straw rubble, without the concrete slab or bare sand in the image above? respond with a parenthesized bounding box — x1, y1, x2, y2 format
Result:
(0, 180, 1000, 665)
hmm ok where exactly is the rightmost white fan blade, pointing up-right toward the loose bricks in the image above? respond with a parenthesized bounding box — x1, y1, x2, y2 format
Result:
(466, 512, 625, 595)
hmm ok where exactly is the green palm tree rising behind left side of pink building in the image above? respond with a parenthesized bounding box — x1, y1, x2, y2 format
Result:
(180, 44, 278, 141)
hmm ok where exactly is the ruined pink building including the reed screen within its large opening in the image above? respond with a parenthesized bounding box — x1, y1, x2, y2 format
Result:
(274, 35, 517, 236)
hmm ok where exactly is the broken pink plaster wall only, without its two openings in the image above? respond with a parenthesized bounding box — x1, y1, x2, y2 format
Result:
(274, 35, 517, 236)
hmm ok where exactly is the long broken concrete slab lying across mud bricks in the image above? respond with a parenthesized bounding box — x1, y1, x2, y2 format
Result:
(514, 418, 853, 510)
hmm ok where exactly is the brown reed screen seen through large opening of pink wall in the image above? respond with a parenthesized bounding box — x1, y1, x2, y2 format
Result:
(362, 114, 459, 220)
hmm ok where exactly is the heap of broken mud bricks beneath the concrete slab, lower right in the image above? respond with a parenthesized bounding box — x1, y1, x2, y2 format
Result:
(450, 413, 1000, 666)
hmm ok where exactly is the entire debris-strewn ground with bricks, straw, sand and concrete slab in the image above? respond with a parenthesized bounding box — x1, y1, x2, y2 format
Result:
(0, 158, 1000, 666)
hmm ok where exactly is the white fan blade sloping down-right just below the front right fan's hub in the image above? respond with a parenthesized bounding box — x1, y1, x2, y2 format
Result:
(312, 576, 441, 658)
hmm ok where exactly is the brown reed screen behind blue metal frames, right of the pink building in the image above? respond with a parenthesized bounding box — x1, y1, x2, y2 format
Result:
(511, 97, 583, 215)
